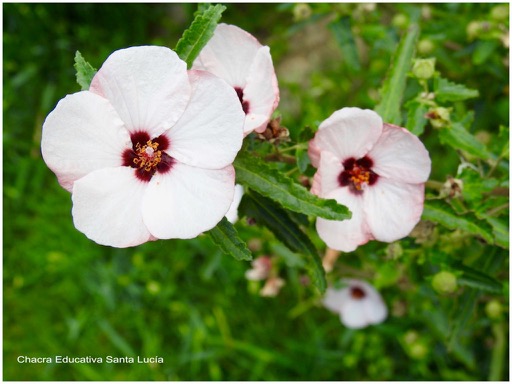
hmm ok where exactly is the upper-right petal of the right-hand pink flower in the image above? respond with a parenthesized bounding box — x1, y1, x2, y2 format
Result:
(369, 124, 430, 184)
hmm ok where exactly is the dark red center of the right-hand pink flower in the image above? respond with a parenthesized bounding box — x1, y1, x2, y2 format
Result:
(338, 156, 379, 194)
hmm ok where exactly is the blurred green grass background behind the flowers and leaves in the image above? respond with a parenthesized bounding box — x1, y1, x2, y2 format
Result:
(3, 3, 509, 381)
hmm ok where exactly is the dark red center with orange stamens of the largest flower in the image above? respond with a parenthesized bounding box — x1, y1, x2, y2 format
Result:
(123, 131, 175, 182)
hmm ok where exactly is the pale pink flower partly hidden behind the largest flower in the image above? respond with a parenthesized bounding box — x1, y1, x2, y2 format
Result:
(192, 24, 279, 135)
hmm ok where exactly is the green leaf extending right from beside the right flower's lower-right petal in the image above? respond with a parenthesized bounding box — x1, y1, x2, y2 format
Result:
(423, 200, 494, 244)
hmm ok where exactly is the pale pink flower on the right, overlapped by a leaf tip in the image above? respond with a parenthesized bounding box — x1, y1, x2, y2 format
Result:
(309, 108, 430, 252)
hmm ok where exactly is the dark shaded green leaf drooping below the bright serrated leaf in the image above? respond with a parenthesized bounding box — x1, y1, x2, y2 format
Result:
(239, 190, 327, 293)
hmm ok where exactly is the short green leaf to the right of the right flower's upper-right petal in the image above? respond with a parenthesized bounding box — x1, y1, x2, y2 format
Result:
(439, 123, 496, 160)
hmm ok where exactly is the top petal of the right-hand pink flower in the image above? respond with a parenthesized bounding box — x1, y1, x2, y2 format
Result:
(313, 108, 382, 161)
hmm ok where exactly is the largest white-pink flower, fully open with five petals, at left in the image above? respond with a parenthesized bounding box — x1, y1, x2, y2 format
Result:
(41, 46, 244, 247)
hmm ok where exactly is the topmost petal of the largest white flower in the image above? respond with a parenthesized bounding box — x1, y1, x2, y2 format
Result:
(90, 46, 190, 137)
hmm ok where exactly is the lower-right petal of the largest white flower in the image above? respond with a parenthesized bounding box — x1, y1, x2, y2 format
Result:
(142, 162, 235, 239)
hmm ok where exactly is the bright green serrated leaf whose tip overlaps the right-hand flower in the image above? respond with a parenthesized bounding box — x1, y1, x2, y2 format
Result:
(234, 152, 352, 220)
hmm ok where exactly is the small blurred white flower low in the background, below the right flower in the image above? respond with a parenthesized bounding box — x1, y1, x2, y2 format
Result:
(323, 279, 388, 329)
